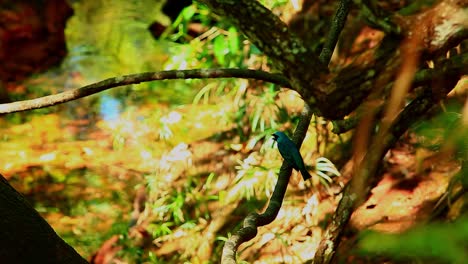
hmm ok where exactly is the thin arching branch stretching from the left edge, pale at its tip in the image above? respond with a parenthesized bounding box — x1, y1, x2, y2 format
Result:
(0, 69, 291, 114)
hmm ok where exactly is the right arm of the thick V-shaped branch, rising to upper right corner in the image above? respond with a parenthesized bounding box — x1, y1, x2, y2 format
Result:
(317, 0, 468, 119)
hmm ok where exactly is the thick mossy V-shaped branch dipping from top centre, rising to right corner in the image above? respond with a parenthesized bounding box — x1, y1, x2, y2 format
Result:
(199, 0, 468, 119)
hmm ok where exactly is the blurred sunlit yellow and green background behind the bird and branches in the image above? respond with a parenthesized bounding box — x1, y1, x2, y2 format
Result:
(0, 0, 468, 263)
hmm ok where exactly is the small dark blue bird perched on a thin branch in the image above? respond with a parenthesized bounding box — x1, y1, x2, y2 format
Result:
(272, 131, 312, 181)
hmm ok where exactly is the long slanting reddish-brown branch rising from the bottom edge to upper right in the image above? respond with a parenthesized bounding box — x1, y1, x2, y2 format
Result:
(314, 3, 466, 252)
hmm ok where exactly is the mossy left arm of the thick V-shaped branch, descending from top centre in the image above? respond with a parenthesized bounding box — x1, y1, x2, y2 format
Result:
(199, 0, 328, 115)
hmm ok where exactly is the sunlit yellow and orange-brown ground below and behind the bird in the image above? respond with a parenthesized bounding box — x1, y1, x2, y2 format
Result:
(0, 101, 459, 263)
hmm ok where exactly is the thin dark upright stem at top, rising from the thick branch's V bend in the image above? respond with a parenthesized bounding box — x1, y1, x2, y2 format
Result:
(319, 0, 351, 64)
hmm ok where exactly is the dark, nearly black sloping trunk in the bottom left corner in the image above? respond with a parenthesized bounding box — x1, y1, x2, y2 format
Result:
(0, 174, 88, 263)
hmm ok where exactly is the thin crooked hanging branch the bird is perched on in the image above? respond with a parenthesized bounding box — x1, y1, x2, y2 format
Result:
(221, 104, 312, 264)
